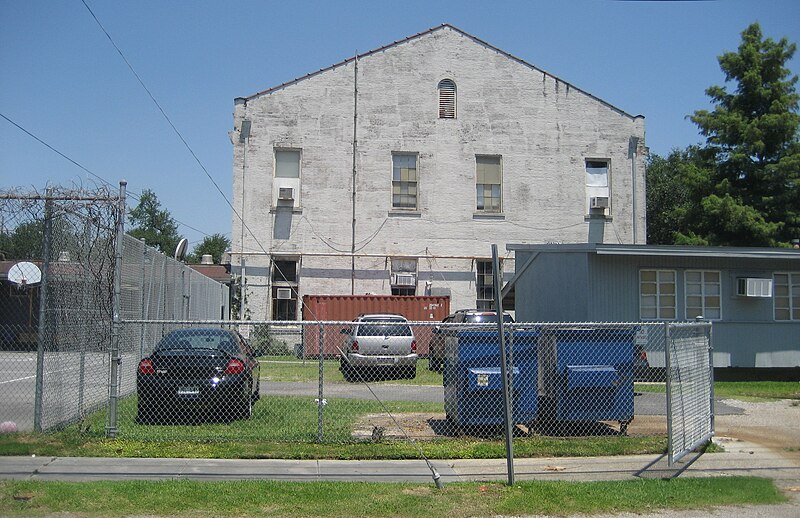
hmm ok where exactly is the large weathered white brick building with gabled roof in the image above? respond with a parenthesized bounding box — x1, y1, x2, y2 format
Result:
(231, 25, 646, 319)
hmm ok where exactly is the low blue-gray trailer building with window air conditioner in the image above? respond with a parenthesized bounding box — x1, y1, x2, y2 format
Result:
(507, 244, 800, 379)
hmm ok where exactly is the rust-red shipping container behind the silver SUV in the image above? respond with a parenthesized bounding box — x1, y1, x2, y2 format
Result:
(303, 295, 450, 357)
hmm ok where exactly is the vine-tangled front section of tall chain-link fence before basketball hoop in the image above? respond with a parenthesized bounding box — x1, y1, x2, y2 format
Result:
(0, 188, 122, 430)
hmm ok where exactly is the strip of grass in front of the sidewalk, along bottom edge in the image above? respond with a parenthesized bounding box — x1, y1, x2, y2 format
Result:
(0, 477, 786, 518)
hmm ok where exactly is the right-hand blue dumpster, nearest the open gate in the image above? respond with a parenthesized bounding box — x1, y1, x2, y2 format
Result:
(538, 326, 636, 432)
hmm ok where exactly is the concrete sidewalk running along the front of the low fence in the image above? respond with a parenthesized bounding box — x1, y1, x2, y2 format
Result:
(0, 438, 800, 488)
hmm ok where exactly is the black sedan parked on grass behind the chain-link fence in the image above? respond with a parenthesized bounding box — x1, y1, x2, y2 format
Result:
(136, 328, 260, 423)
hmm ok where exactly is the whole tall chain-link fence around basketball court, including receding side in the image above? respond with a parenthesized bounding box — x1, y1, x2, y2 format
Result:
(0, 187, 229, 435)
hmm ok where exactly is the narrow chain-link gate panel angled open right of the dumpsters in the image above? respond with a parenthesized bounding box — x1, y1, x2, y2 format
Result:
(666, 322, 714, 465)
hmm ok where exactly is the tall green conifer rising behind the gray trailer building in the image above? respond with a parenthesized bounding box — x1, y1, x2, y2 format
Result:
(675, 23, 800, 246)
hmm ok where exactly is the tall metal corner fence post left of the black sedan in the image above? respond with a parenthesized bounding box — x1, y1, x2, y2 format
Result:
(106, 180, 128, 439)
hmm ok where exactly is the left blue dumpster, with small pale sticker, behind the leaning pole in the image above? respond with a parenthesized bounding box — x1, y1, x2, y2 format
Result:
(442, 330, 538, 426)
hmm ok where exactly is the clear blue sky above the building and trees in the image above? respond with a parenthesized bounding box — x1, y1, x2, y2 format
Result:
(0, 0, 800, 250)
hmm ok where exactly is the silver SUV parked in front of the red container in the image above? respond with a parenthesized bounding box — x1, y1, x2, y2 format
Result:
(339, 314, 417, 381)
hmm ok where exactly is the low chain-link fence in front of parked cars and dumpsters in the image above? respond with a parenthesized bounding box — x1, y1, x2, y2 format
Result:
(101, 317, 680, 443)
